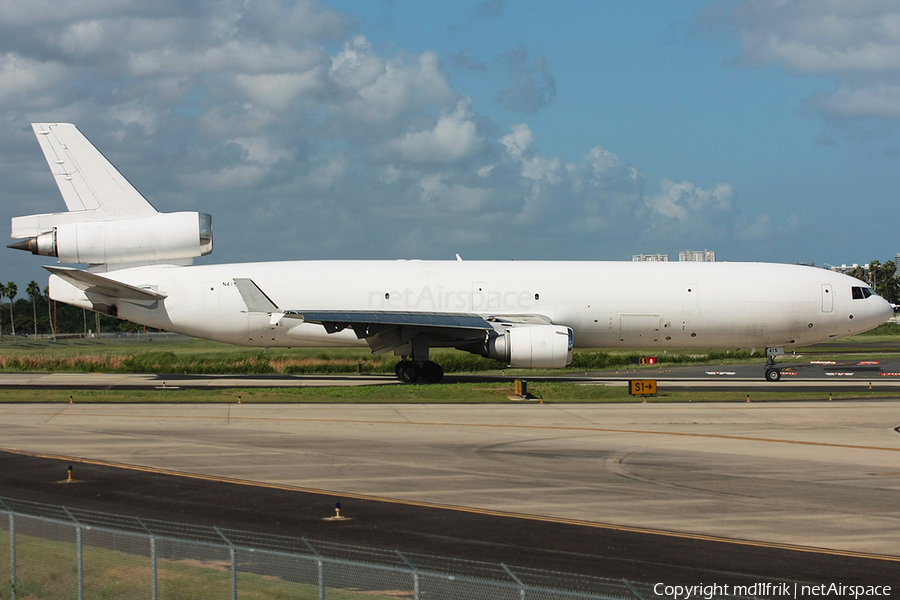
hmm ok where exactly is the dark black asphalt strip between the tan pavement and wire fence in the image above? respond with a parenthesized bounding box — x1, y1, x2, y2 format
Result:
(0, 452, 900, 585)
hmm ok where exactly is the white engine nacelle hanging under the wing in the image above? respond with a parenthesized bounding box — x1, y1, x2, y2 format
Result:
(485, 325, 575, 369)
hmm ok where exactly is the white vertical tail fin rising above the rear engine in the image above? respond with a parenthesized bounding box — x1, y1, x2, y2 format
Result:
(32, 123, 156, 219)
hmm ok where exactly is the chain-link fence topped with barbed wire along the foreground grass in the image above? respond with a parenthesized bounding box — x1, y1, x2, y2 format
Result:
(0, 498, 760, 600)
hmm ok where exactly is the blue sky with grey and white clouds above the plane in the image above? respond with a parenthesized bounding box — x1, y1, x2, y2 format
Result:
(0, 0, 900, 283)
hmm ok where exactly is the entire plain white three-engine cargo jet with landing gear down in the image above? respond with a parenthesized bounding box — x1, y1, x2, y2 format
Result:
(10, 123, 892, 382)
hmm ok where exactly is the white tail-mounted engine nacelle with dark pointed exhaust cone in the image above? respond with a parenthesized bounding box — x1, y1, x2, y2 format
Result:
(10, 212, 212, 264)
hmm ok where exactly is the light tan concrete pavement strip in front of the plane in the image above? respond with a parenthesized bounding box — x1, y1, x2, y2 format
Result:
(0, 400, 900, 576)
